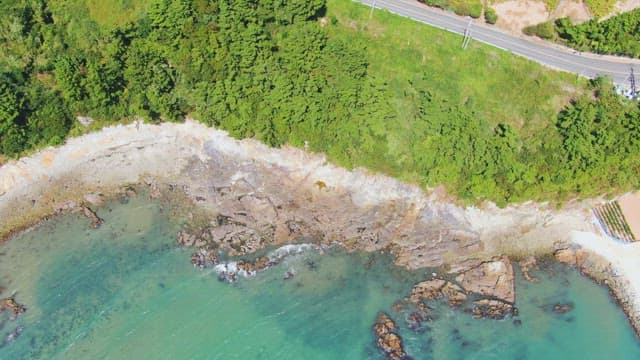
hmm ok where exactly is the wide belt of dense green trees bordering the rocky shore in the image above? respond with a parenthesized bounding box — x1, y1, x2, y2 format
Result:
(0, 0, 640, 204)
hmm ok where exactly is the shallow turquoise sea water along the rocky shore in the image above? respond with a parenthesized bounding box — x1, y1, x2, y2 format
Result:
(0, 199, 640, 359)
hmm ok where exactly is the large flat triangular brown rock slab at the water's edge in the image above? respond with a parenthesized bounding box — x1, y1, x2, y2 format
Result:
(456, 257, 516, 303)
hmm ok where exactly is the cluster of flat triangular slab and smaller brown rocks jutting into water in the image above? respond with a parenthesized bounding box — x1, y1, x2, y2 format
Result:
(408, 257, 517, 325)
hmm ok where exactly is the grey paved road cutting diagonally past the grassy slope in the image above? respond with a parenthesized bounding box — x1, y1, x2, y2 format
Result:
(354, 0, 640, 87)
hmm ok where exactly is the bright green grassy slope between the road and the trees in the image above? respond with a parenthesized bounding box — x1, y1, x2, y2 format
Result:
(327, 0, 586, 150)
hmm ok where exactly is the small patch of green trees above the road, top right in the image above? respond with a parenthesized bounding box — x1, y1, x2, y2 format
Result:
(524, 9, 640, 58)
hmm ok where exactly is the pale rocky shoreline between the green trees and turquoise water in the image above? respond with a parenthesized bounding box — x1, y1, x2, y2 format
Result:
(0, 121, 640, 344)
